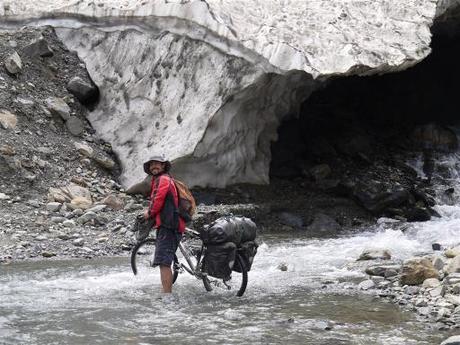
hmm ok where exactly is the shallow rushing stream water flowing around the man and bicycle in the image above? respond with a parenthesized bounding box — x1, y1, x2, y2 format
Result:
(0, 154, 460, 345)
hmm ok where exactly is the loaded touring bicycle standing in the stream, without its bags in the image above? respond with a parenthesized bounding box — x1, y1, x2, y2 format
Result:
(131, 228, 248, 297)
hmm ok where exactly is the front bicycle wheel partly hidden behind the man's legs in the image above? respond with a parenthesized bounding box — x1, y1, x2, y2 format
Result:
(131, 238, 179, 284)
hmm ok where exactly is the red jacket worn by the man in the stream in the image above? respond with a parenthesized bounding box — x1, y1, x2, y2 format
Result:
(149, 174, 185, 233)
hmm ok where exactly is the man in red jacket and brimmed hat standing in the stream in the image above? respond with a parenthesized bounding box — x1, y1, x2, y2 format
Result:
(144, 157, 185, 293)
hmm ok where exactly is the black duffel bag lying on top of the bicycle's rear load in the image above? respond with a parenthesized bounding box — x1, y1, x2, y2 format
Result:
(201, 216, 257, 246)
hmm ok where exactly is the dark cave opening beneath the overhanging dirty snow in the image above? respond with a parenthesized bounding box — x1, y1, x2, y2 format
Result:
(270, 20, 460, 179)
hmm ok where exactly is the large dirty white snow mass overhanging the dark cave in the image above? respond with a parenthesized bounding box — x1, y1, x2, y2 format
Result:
(0, 0, 459, 187)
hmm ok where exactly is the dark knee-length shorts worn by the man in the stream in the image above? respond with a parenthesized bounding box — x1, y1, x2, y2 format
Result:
(153, 226, 182, 266)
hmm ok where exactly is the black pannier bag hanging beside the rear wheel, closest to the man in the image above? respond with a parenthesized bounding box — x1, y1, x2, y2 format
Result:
(204, 242, 236, 280)
